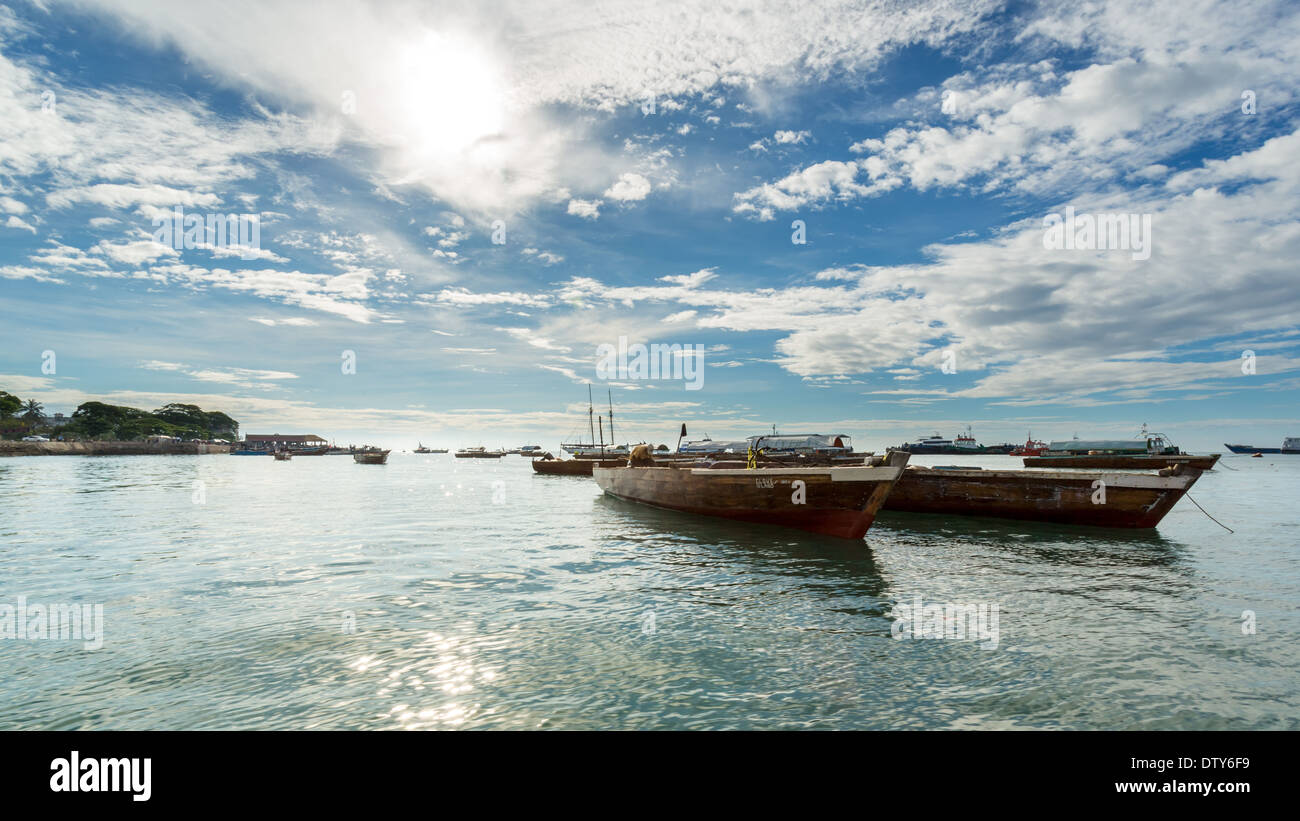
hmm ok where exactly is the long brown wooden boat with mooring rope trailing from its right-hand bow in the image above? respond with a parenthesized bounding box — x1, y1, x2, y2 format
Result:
(884, 465, 1201, 527)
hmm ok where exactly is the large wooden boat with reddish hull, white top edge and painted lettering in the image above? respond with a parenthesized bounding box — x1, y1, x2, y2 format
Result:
(592, 453, 907, 539)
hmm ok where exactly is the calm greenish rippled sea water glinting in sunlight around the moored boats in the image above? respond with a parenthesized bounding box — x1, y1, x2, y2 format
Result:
(0, 453, 1300, 730)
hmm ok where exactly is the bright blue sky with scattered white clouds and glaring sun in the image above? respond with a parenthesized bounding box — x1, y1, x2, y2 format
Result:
(0, 0, 1300, 449)
